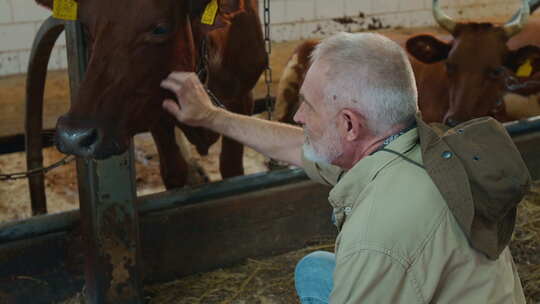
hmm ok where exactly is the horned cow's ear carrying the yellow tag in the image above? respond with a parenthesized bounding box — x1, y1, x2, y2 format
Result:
(505, 45, 540, 77)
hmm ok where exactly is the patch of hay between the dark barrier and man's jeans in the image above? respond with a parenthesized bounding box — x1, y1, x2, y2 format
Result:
(145, 238, 334, 304)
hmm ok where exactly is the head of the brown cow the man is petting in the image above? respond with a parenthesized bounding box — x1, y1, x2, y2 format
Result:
(36, 0, 231, 159)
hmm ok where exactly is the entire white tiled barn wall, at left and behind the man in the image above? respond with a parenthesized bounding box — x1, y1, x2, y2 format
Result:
(0, 0, 518, 76)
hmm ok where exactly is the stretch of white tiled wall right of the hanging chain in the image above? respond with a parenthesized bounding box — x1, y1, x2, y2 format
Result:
(259, 0, 521, 41)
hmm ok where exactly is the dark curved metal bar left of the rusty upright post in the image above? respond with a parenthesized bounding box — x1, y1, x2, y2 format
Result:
(25, 17, 64, 215)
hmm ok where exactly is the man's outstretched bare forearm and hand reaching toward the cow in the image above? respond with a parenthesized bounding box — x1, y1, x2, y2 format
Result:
(161, 72, 304, 166)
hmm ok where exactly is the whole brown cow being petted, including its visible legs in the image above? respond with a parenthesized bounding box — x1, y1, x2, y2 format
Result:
(37, 0, 267, 188)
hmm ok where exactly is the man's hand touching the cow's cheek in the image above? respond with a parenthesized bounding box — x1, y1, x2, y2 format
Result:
(161, 72, 219, 127)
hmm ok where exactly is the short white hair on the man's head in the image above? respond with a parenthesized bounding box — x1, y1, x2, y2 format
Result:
(311, 33, 418, 135)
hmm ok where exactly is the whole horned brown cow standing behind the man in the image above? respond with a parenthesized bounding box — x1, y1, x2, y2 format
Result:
(274, 0, 540, 125)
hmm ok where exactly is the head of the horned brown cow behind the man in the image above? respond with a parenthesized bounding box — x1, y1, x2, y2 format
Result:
(407, 0, 540, 125)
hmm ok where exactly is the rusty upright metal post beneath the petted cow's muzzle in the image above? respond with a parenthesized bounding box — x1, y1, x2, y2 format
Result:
(66, 21, 143, 304)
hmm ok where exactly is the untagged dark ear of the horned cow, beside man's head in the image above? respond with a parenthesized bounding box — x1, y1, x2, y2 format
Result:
(406, 35, 452, 63)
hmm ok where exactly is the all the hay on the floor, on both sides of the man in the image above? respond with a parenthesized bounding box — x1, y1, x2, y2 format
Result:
(57, 181, 540, 304)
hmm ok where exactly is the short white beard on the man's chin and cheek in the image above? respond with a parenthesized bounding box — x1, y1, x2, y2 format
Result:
(302, 127, 342, 165)
